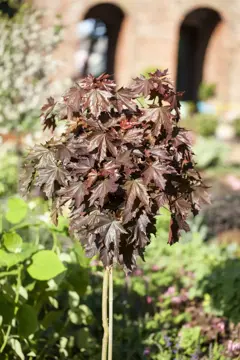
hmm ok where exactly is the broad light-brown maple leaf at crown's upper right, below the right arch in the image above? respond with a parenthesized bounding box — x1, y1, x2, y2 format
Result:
(139, 106, 172, 136)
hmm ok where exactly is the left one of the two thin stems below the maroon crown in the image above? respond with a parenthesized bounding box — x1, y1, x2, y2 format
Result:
(102, 269, 109, 360)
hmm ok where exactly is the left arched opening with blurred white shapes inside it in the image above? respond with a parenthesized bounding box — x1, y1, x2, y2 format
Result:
(76, 3, 124, 76)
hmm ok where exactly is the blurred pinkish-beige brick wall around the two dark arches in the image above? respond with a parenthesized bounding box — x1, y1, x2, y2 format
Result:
(35, 0, 240, 106)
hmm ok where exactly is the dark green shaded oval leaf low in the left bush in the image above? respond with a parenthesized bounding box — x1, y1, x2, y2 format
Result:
(17, 304, 38, 338)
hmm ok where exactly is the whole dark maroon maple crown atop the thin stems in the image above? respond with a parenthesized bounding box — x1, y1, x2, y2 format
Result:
(21, 70, 209, 271)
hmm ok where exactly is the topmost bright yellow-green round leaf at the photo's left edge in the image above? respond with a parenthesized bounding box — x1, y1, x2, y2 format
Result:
(5, 198, 28, 224)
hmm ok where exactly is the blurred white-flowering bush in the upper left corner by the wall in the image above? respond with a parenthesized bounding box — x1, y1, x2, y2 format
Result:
(0, 1, 69, 135)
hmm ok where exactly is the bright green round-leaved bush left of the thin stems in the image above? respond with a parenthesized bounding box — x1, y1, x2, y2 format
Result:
(0, 197, 98, 360)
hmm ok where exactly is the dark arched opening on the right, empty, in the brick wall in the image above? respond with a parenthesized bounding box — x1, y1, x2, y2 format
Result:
(177, 8, 221, 101)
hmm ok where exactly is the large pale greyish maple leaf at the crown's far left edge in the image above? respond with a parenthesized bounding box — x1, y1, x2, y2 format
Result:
(36, 159, 68, 199)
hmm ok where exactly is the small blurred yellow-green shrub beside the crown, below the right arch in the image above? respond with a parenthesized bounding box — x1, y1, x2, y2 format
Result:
(183, 113, 218, 137)
